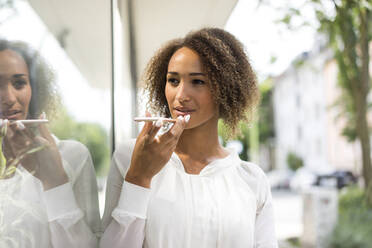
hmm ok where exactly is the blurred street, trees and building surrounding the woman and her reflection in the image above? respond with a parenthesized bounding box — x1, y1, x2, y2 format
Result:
(0, 0, 372, 248)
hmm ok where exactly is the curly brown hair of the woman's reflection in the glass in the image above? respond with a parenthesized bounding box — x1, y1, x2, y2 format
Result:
(0, 38, 60, 119)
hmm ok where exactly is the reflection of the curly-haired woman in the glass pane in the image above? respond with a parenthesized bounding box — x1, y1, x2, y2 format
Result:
(0, 39, 100, 248)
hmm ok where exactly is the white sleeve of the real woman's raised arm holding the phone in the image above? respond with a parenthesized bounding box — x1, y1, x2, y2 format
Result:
(100, 140, 150, 248)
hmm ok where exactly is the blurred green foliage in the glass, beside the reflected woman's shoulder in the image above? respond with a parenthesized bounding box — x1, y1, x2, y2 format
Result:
(50, 109, 110, 174)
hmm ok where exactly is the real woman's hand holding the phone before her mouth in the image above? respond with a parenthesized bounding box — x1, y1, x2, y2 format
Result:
(125, 115, 190, 188)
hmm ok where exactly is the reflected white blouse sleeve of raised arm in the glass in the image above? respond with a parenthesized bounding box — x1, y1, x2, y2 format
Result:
(44, 140, 100, 248)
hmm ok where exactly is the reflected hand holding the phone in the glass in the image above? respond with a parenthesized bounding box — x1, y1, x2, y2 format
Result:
(4, 115, 68, 190)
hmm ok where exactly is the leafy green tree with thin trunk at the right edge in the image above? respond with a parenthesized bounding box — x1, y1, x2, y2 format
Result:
(274, 0, 372, 205)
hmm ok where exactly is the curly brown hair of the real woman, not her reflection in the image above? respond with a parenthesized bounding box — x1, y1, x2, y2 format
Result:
(143, 28, 260, 133)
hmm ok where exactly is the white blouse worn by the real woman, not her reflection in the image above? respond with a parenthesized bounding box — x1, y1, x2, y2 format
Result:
(100, 140, 277, 248)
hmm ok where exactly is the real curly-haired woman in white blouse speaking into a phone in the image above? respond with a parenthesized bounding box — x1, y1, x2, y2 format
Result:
(101, 28, 277, 248)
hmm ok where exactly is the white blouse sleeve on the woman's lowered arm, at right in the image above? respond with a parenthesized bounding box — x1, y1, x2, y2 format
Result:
(254, 172, 278, 248)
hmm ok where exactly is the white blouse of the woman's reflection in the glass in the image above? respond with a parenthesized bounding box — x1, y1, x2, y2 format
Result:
(0, 139, 101, 248)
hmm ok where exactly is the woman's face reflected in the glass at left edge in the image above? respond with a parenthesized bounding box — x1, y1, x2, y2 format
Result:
(0, 49, 31, 120)
